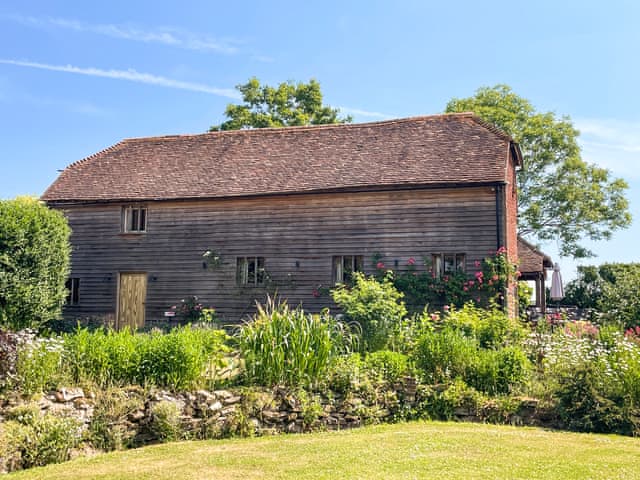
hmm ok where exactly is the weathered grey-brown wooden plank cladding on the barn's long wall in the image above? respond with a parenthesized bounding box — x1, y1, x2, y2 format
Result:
(60, 186, 497, 326)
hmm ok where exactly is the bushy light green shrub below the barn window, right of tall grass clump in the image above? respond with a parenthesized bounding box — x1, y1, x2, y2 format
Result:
(331, 272, 407, 352)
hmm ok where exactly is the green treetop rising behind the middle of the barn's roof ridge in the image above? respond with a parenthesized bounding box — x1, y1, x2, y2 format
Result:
(209, 77, 352, 132)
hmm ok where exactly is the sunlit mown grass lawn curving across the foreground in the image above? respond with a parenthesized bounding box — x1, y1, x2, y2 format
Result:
(8, 422, 640, 480)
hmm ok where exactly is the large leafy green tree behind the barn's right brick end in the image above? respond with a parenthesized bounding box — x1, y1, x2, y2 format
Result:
(446, 85, 631, 258)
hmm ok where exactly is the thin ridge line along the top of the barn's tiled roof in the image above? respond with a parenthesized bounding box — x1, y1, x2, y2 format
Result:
(119, 112, 480, 142)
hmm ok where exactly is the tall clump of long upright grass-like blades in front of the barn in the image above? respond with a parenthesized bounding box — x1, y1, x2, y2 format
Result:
(238, 298, 345, 386)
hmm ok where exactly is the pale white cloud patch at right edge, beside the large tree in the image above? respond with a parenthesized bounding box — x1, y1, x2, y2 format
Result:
(574, 118, 640, 179)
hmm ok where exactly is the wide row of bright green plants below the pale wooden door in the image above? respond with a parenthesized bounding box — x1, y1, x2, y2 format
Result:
(64, 325, 229, 389)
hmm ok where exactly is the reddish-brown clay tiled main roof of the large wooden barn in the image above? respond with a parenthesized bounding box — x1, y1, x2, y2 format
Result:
(42, 113, 517, 202)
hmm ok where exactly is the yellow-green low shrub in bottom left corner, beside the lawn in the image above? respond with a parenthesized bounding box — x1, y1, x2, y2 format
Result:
(0, 409, 81, 470)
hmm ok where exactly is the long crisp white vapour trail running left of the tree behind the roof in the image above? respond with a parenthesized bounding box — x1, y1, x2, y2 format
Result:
(0, 59, 240, 100)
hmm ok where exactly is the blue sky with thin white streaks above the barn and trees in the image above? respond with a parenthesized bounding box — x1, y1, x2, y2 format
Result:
(0, 0, 640, 277)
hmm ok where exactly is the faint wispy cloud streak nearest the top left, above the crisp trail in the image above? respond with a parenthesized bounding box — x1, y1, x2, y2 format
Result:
(0, 14, 238, 54)
